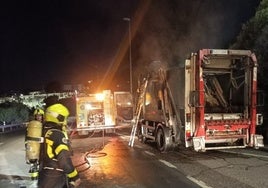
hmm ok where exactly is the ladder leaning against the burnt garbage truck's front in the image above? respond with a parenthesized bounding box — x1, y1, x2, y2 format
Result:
(128, 77, 148, 147)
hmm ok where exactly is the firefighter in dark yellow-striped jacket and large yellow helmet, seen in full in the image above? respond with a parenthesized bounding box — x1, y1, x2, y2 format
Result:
(38, 104, 81, 188)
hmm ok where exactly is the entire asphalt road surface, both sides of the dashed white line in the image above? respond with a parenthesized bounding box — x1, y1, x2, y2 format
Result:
(0, 129, 268, 188)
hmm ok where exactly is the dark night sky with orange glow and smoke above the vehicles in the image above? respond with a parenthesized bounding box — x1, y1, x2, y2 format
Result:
(0, 0, 259, 93)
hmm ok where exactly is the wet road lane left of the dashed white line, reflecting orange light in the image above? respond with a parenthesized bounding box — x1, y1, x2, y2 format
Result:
(0, 129, 199, 188)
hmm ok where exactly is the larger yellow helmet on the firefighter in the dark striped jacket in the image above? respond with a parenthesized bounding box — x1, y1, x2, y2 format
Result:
(45, 103, 69, 125)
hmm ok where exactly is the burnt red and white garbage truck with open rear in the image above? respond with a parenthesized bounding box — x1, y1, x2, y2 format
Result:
(139, 49, 263, 152)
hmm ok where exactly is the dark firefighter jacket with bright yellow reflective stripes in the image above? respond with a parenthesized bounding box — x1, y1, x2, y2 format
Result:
(40, 122, 79, 181)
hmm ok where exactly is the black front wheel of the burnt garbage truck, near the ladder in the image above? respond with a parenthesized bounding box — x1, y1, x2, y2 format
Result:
(156, 127, 174, 152)
